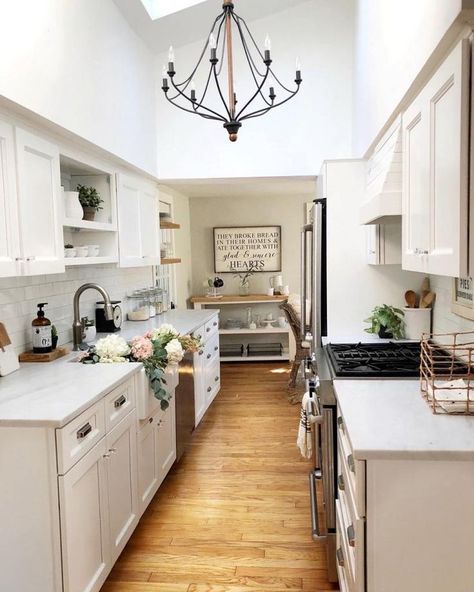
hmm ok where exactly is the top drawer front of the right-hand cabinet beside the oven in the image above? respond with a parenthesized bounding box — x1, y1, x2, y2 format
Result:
(337, 413, 365, 517)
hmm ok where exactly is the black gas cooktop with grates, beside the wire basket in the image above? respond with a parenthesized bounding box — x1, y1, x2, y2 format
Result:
(326, 342, 421, 378)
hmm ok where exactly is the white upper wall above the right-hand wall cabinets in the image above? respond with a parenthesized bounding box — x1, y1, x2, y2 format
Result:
(353, 0, 462, 157)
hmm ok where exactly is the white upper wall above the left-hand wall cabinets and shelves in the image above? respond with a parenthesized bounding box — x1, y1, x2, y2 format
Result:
(0, 0, 156, 174)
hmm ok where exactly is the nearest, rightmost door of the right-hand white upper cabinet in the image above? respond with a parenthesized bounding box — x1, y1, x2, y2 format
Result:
(424, 39, 470, 277)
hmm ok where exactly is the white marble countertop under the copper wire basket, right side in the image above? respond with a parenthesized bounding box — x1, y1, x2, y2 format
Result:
(334, 380, 474, 460)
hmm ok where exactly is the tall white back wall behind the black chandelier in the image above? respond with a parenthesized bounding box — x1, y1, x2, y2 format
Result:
(157, 0, 353, 179)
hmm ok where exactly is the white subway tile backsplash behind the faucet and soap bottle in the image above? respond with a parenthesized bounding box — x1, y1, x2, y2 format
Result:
(0, 265, 152, 354)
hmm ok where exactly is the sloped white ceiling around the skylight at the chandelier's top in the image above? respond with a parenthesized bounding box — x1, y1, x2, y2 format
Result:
(114, 0, 307, 53)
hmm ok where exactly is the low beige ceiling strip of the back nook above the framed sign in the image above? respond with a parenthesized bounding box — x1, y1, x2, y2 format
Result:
(161, 177, 316, 201)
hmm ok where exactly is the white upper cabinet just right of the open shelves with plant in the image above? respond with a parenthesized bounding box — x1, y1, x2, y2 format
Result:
(117, 175, 160, 267)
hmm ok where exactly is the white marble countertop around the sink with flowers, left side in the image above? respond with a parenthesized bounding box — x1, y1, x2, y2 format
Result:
(0, 309, 217, 427)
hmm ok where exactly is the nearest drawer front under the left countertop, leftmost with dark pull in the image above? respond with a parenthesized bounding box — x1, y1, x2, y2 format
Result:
(56, 400, 105, 475)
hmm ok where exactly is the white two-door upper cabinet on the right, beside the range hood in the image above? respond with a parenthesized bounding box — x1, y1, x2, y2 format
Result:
(403, 39, 470, 277)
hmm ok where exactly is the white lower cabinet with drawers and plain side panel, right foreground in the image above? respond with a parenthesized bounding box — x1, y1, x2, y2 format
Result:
(336, 412, 474, 592)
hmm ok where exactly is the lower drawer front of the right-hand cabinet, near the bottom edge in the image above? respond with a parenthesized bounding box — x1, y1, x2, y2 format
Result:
(336, 484, 365, 592)
